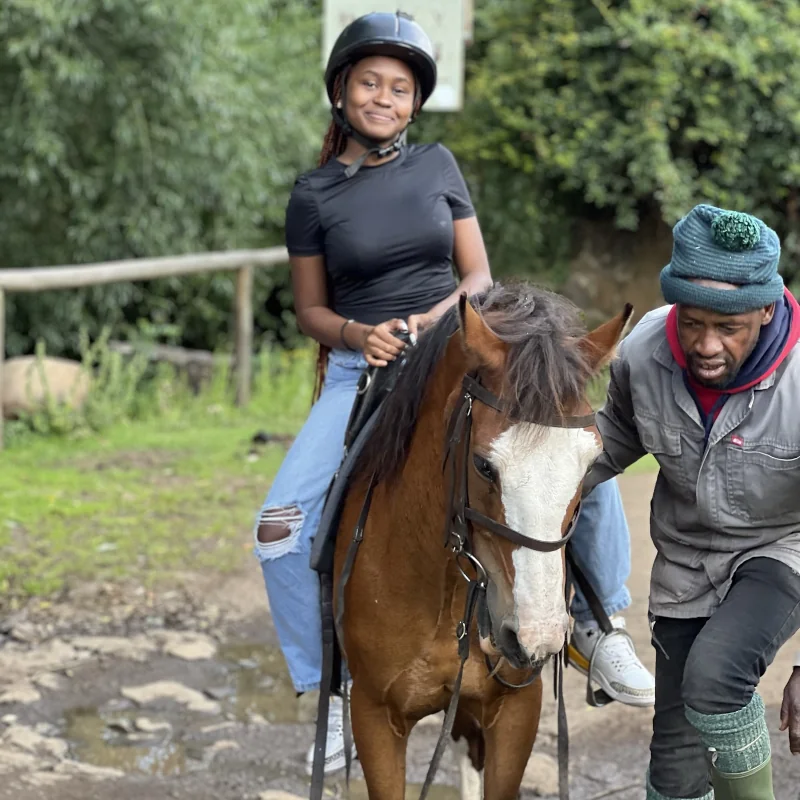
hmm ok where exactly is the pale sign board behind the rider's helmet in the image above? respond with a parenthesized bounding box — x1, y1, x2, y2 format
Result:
(322, 0, 472, 111)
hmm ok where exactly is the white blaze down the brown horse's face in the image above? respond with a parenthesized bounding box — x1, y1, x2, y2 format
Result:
(490, 423, 601, 659)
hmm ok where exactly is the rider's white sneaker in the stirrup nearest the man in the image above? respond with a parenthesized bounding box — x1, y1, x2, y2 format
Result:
(569, 617, 656, 706)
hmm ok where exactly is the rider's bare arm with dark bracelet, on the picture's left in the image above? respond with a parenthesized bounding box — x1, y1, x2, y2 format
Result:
(289, 256, 405, 366)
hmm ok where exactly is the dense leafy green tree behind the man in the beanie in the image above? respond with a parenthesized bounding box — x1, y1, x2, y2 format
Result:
(423, 0, 800, 282)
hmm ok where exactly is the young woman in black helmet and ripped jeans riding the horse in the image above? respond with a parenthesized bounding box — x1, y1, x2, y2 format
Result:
(256, 7, 652, 772)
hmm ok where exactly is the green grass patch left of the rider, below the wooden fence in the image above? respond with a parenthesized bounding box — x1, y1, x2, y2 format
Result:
(0, 346, 313, 602)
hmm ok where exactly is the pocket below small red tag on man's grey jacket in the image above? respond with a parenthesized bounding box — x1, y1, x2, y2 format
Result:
(725, 445, 800, 523)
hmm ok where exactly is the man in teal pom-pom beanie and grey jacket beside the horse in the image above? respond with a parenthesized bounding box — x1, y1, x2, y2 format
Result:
(585, 205, 800, 800)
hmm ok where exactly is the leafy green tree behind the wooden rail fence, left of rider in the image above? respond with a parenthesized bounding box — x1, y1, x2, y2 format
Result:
(0, 0, 325, 353)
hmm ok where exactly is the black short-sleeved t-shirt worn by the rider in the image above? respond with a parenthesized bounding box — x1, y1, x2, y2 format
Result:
(286, 144, 475, 325)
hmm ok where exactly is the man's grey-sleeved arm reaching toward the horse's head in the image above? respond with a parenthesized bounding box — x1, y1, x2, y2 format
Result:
(583, 340, 647, 497)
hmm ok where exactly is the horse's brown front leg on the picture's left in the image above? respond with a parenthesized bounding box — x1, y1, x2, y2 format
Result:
(351, 681, 410, 800)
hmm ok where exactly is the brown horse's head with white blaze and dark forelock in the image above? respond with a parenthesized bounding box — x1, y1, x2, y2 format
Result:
(447, 285, 633, 667)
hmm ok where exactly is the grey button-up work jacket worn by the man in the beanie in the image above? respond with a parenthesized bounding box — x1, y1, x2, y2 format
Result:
(584, 307, 800, 617)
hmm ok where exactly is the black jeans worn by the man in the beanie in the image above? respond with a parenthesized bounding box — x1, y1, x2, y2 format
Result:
(650, 558, 800, 798)
